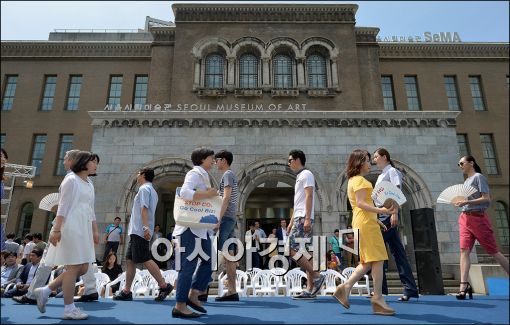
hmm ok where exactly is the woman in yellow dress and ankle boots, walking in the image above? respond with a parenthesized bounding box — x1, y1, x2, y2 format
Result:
(333, 149, 395, 315)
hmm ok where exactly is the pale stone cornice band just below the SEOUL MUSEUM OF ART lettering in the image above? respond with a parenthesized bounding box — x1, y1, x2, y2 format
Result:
(88, 111, 459, 128)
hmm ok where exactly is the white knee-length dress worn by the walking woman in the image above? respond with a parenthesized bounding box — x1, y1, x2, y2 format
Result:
(44, 173, 96, 265)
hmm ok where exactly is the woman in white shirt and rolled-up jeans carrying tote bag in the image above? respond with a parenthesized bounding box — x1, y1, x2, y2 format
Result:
(172, 148, 218, 318)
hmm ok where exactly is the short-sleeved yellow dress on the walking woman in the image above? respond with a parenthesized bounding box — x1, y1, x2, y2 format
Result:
(347, 175, 388, 263)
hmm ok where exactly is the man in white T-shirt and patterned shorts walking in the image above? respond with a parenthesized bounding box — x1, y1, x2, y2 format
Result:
(287, 150, 326, 300)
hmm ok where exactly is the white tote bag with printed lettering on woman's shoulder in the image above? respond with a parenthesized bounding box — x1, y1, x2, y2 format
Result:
(174, 170, 223, 229)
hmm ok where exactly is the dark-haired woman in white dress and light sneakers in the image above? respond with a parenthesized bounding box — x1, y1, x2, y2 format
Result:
(34, 151, 99, 319)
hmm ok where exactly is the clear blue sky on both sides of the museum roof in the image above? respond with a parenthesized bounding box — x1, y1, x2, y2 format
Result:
(1, 1, 509, 42)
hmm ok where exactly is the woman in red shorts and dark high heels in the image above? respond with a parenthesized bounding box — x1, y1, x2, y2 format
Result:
(454, 156, 508, 300)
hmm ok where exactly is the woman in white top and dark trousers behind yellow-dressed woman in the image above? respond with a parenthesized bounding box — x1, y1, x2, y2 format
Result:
(374, 148, 418, 301)
